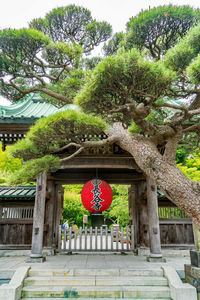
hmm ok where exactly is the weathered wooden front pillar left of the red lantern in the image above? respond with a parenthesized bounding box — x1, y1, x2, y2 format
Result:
(30, 172, 47, 262)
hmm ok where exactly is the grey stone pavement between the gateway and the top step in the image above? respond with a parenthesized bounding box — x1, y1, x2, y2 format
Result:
(0, 250, 190, 271)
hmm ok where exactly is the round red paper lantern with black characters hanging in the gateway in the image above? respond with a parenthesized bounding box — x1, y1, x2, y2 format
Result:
(81, 179, 113, 212)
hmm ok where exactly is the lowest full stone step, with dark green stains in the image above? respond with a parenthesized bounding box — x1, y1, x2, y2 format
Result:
(22, 286, 170, 299)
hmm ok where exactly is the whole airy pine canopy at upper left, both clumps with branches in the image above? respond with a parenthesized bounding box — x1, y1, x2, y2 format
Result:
(0, 5, 112, 104)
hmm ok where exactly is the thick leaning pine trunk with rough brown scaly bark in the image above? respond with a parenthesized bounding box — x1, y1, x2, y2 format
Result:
(108, 123, 200, 229)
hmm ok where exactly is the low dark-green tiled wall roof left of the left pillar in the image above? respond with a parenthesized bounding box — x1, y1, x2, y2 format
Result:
(0, 185, 36, 199)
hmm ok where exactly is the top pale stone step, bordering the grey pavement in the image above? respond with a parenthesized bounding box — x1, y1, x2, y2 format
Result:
(29, 268, 163, 277)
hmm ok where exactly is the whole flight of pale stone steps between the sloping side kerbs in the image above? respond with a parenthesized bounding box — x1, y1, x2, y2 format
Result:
(21, 269, 171, 300)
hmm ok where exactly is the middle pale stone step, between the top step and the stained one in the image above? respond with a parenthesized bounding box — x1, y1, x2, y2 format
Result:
(24, 276, 168, 286)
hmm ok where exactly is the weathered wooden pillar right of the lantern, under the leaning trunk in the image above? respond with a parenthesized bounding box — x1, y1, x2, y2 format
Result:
(147, 177, 162, 261)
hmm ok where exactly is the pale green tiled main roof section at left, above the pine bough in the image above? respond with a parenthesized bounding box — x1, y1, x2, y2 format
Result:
(0, 94, 77, 123)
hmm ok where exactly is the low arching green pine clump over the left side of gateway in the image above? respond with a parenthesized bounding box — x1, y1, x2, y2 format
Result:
(11, 110, 106, 160)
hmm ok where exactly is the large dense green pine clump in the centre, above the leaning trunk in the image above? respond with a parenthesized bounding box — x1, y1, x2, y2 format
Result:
(75, 49, 175, 118)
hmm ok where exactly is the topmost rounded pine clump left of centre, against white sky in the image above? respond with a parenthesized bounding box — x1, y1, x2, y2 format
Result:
(30, 5, 112, 53)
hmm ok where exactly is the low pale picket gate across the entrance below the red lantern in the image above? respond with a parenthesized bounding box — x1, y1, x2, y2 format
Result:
(59, 226, 134, 252)
